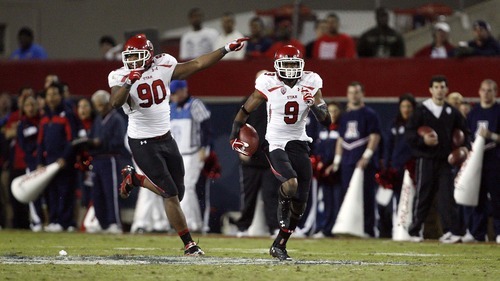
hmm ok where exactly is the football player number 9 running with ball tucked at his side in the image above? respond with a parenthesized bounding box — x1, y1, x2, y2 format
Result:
(229, 45, 331, 261)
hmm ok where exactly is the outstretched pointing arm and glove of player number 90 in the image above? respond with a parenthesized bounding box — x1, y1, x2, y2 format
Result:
(172, 37, 250, 80)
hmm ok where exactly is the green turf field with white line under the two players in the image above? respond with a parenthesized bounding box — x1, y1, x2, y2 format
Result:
(0, 230, 500, 281)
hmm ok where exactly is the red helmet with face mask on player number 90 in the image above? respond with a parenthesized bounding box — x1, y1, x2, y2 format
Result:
(122, 34, 154, 69)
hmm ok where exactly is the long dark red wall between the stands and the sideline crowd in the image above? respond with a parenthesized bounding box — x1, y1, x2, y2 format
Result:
(0, 58, 500, 98)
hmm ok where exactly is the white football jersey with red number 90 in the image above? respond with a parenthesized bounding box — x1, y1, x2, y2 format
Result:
(108, 54, 177, 139)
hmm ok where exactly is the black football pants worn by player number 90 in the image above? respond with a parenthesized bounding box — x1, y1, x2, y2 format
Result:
(128, 132, 185, 200)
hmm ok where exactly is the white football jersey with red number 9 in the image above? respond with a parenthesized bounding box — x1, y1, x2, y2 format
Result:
(255, 71, 323, 151)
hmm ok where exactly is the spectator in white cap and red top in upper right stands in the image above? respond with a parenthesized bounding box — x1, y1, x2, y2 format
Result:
(413, 22, 455, 59)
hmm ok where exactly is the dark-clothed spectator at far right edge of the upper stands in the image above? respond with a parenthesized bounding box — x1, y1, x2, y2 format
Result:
(455, 20, 500, 57)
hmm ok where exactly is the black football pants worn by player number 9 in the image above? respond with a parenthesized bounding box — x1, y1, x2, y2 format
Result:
(269, 141, 312, 200)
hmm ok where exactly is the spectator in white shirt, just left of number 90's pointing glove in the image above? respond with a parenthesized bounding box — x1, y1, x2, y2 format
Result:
(179, 8, 219, 60)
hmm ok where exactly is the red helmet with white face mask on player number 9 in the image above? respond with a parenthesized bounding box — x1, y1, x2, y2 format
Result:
(274, 45, 304, 79)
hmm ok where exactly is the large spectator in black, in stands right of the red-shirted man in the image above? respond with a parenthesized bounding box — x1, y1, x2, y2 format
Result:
(358, 7, 405, 58)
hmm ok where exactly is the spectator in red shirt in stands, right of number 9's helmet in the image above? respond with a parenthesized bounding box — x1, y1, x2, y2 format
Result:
(312, 14, 356, 59)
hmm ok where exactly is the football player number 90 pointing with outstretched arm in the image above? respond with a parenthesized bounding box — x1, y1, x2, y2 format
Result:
(108, 34, 248, 256)
